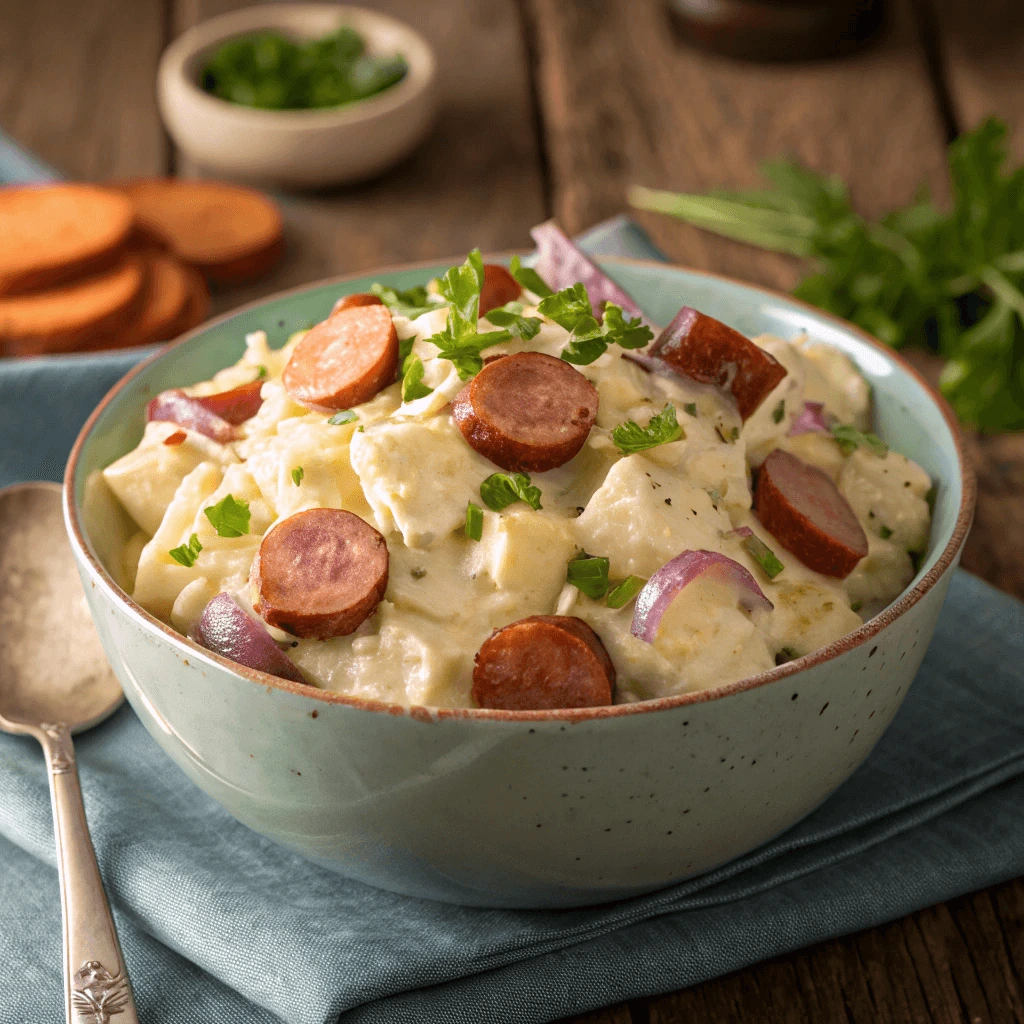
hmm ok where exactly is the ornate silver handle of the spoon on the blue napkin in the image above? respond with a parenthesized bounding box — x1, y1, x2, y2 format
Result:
(40, 722, 138, 1024)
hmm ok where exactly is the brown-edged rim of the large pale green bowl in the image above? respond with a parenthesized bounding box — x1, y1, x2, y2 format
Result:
(63, 250, 977, 723)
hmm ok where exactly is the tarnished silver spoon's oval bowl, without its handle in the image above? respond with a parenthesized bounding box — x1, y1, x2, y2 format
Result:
(0, 483, 124, 733)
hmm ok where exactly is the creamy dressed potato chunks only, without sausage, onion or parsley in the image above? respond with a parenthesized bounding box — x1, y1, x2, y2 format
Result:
(103, 299, 932, 707)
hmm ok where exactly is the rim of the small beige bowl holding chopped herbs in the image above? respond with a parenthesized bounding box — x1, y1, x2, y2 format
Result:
(157, 3, 437, 131)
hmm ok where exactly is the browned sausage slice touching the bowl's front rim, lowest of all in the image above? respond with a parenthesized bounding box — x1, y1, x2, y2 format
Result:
(473, 615, 615, 711)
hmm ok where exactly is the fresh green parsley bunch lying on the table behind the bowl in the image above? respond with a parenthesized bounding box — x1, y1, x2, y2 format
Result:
(630, 119, 1024, 432)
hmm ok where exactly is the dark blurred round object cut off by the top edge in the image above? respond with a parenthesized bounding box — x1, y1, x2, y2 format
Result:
(668, 0, 882, 60)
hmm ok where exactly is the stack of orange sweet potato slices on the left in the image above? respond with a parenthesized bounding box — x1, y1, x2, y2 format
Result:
(0, 178, 284, 355)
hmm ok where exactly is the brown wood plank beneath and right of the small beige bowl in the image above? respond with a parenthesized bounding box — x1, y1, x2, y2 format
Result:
(172, 0, 546, 309)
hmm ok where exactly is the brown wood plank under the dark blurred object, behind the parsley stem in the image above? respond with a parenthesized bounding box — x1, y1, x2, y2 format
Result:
(522, 0, 946, 288)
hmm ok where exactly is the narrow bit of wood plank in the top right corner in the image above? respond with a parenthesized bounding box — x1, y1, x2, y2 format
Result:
(931, 0, 1024, 156)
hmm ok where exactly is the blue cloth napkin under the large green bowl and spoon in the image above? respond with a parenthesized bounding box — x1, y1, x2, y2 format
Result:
(0, 222, 1024, 1024)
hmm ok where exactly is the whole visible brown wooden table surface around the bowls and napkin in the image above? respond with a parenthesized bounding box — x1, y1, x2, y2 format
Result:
(0, 0, 1024, 1024)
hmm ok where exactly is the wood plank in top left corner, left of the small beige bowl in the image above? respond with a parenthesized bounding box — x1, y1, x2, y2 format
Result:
(0, 0, 168, 180)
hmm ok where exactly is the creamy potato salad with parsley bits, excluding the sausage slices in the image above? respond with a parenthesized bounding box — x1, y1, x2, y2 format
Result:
(102, 241, 932, 707)
